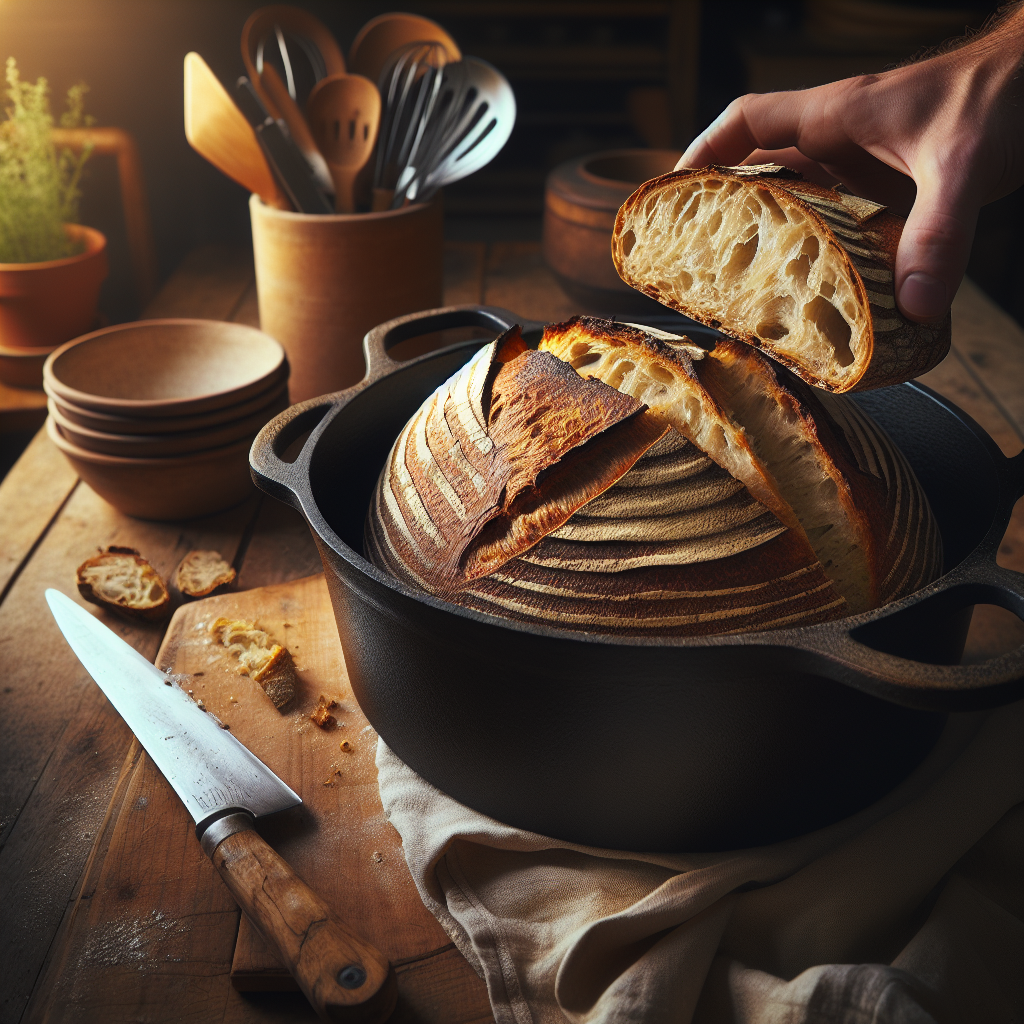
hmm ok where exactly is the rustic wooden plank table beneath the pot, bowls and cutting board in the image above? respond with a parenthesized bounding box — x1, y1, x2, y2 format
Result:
(0, 243, 1024, 1024)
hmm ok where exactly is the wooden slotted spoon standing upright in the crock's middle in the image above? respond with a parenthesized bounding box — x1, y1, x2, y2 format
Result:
(306, 75, 381, 213)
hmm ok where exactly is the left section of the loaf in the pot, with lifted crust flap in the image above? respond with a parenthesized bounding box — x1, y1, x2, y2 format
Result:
(368, 329, 666, 596)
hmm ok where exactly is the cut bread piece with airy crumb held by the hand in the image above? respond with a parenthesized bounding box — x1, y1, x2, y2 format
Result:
(611, 164, 950, 392)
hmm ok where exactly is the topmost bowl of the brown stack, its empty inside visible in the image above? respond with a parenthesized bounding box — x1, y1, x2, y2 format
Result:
(43, 319, 288, 419)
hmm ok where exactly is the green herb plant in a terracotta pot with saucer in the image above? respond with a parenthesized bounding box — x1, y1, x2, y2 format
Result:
(0, 57, 108, 387)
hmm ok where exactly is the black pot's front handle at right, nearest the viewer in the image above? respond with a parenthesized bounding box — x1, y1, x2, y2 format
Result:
(780, 452, 1024, 712)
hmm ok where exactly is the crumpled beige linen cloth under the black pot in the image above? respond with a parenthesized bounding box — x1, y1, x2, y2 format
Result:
(377, 701, 1024, 1024)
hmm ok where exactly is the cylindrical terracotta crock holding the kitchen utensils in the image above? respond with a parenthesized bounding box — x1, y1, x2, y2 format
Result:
(249, 196, 444, 401)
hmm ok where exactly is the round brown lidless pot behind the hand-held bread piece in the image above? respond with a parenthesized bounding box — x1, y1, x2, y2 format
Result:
(544, 150, 682, 313)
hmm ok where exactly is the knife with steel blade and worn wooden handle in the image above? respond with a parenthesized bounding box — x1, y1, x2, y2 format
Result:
(46, 590, 396, 1022)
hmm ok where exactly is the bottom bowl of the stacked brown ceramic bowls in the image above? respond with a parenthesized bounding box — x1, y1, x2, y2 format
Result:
(46, 418, 253, 521)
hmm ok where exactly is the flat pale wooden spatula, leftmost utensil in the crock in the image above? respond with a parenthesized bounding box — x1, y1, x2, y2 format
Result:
(185, 52, 292, 210)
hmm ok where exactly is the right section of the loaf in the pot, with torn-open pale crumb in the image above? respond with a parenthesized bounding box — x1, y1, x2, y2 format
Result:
(541, 317, 942, 612)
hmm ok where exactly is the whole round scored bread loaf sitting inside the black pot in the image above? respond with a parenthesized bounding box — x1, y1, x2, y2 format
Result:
(366, 317, 941, 636)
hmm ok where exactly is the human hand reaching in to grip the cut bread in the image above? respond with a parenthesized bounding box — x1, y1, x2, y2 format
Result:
(677, 4, 1024, 323)
